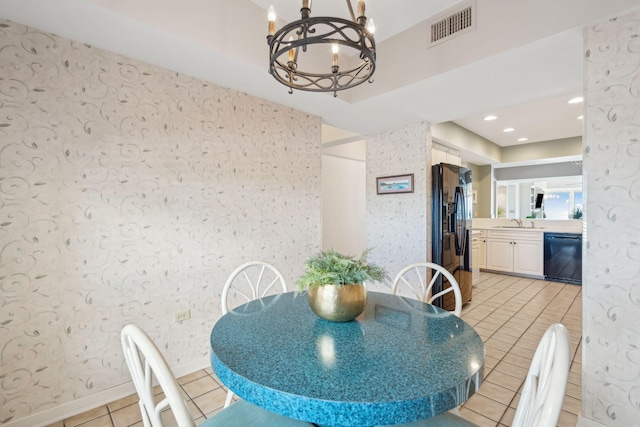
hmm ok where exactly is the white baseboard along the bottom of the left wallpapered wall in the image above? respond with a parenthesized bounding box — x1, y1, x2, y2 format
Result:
(2, 356, 211, 427)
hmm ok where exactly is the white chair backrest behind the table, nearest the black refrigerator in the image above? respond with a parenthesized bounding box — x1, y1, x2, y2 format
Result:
(392, 262, 462, 317)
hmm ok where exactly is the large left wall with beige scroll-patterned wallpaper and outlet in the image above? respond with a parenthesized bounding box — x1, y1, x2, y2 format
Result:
(0, 20, 321, 423)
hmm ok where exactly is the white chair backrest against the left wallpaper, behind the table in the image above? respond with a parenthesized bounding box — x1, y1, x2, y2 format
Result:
(221, 261, 287, 314)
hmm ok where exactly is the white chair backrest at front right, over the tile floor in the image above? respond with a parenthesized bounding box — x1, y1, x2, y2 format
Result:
(511, 323, 571, 427)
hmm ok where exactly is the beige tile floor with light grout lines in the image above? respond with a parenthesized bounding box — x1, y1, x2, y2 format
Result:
(49, 272, 582, 427)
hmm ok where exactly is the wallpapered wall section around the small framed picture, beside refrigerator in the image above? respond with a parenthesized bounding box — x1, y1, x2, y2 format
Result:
(367, 123, 431, 292)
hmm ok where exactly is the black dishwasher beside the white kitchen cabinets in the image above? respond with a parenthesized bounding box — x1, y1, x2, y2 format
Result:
(544, 233, 582, 285)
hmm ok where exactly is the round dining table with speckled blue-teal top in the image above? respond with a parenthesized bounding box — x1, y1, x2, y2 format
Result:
(211, 292, 485, 427)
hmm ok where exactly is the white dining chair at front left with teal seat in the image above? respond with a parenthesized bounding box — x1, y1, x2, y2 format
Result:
(121, 324, 312, 427)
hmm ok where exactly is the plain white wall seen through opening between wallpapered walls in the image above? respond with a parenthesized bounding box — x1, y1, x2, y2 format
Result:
(322, 155, 367, 256)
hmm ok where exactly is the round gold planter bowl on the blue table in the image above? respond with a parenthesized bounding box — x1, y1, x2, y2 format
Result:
(309, 284, 367, 322)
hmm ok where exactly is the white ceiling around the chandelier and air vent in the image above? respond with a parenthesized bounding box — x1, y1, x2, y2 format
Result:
(0, 0, 640, 161)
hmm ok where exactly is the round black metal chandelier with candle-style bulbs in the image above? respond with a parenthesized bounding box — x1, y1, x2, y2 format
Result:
(267, 0, 376, 96)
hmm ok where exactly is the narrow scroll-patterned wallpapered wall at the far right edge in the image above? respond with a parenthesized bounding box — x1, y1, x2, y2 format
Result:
(582, 9, 640, 427)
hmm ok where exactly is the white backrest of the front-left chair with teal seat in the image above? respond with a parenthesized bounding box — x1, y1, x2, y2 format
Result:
(120, 325, 195, 427)
